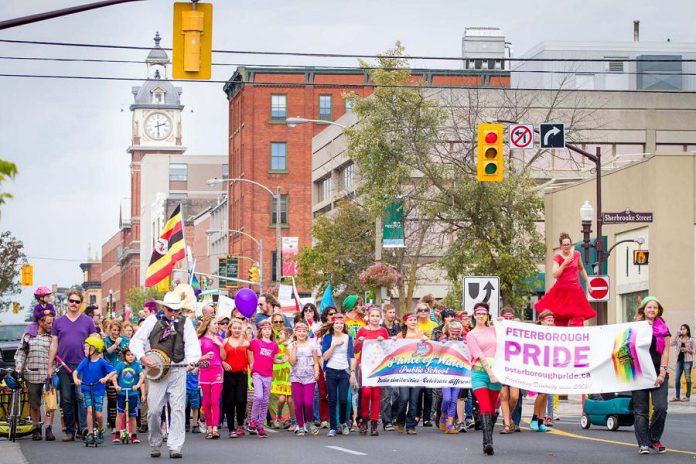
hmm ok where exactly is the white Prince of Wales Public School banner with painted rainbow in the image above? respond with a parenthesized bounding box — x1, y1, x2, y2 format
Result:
(361, 340, 471, 388)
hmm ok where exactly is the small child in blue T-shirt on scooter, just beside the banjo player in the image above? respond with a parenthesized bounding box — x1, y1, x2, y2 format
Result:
(111, 348, 145, 443)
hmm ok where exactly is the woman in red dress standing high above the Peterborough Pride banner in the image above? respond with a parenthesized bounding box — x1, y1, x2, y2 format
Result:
(534, 232, 597, 327)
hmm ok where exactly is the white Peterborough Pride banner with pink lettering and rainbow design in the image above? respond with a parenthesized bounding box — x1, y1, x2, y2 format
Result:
(493, 320, 657, 394)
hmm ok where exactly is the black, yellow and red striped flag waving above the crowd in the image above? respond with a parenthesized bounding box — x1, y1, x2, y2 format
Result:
(145, 204, 186, 287)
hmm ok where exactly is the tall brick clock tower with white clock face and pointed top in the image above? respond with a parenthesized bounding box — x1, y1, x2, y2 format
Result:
(120, 32, 186, 290)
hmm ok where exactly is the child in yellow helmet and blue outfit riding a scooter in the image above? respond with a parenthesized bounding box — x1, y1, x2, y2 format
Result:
(73, 336, 115, 445)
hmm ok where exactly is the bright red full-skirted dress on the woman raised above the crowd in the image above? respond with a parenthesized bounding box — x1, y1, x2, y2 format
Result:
(534, 251, 597, 326)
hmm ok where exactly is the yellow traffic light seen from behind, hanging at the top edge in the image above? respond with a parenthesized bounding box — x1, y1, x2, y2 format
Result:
(172, 2, 213, 80)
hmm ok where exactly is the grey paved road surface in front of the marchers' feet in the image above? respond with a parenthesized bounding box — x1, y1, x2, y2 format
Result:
(10, 414, 696, 464)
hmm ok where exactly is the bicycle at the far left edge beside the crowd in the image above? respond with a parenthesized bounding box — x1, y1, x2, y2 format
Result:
(0, 368, 37, 442)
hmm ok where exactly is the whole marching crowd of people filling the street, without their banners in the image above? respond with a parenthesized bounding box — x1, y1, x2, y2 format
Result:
(4, 234, 694, 458)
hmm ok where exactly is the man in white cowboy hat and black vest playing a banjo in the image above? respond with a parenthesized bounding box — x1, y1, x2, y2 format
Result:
(130, 292, 201, 458)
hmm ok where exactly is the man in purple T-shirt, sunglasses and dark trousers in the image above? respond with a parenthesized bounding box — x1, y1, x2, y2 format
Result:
(48, 289, 97, 441)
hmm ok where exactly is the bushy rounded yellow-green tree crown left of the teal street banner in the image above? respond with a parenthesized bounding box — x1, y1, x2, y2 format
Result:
(296, 201, 375, 295)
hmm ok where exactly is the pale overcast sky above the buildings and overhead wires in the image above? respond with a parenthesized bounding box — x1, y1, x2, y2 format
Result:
(0, 0, 696, 320)
